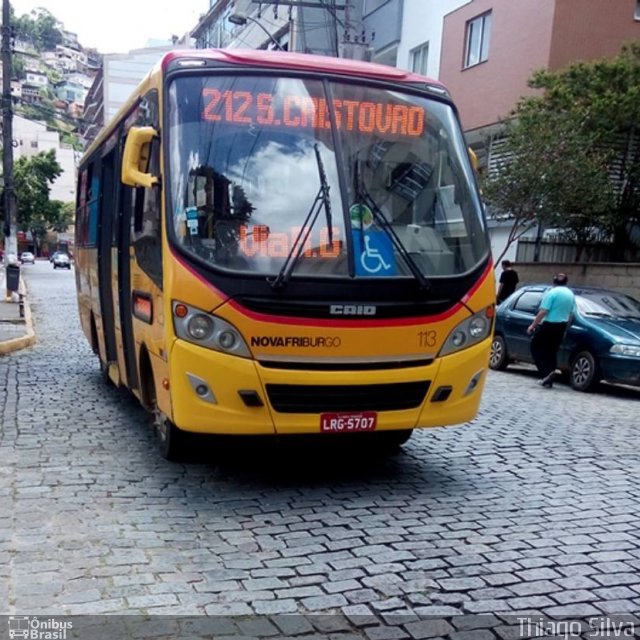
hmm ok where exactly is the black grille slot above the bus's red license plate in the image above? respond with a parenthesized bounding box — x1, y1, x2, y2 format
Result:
(266, 380, 430, 413)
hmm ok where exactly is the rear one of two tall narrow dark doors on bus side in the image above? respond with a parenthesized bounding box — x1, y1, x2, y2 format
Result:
(98, 151, 117, 380)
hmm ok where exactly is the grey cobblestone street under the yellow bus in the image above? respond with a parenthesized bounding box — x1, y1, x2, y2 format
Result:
(0, 264, 640, 638)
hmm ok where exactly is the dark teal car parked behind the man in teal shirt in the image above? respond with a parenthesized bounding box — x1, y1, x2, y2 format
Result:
(489, 285, 640, 391)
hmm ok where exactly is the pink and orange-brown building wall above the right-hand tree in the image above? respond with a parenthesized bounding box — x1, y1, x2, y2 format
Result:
(439, 0, 640, 131)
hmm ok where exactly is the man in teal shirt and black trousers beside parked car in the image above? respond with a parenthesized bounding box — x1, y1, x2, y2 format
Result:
(527, 273, 576, 389)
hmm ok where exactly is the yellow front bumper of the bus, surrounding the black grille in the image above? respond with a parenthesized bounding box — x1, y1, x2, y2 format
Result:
(170, 339, 491, 435)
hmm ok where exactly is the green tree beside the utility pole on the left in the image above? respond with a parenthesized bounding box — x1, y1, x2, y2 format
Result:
(14, 149, 63, 254)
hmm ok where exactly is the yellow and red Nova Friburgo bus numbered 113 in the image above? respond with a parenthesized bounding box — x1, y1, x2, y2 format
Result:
(76, 50, 495, 459)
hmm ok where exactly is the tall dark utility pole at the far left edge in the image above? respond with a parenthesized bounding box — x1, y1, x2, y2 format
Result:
(2, 0, 18, 266)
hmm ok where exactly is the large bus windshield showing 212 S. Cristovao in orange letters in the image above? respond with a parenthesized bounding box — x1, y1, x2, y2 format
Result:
(168, 74, 488, 278)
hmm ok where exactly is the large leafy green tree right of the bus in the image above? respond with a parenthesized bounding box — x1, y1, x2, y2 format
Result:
(483, 44, 640, 263)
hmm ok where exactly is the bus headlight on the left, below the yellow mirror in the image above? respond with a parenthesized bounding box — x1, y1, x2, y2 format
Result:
(171, 300, 251, 358)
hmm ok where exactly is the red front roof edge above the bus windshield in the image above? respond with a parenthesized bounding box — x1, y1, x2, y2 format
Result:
(161, 49, 444, 89)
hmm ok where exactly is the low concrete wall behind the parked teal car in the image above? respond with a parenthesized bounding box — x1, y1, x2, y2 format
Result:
(513, 262, 640, 299)
